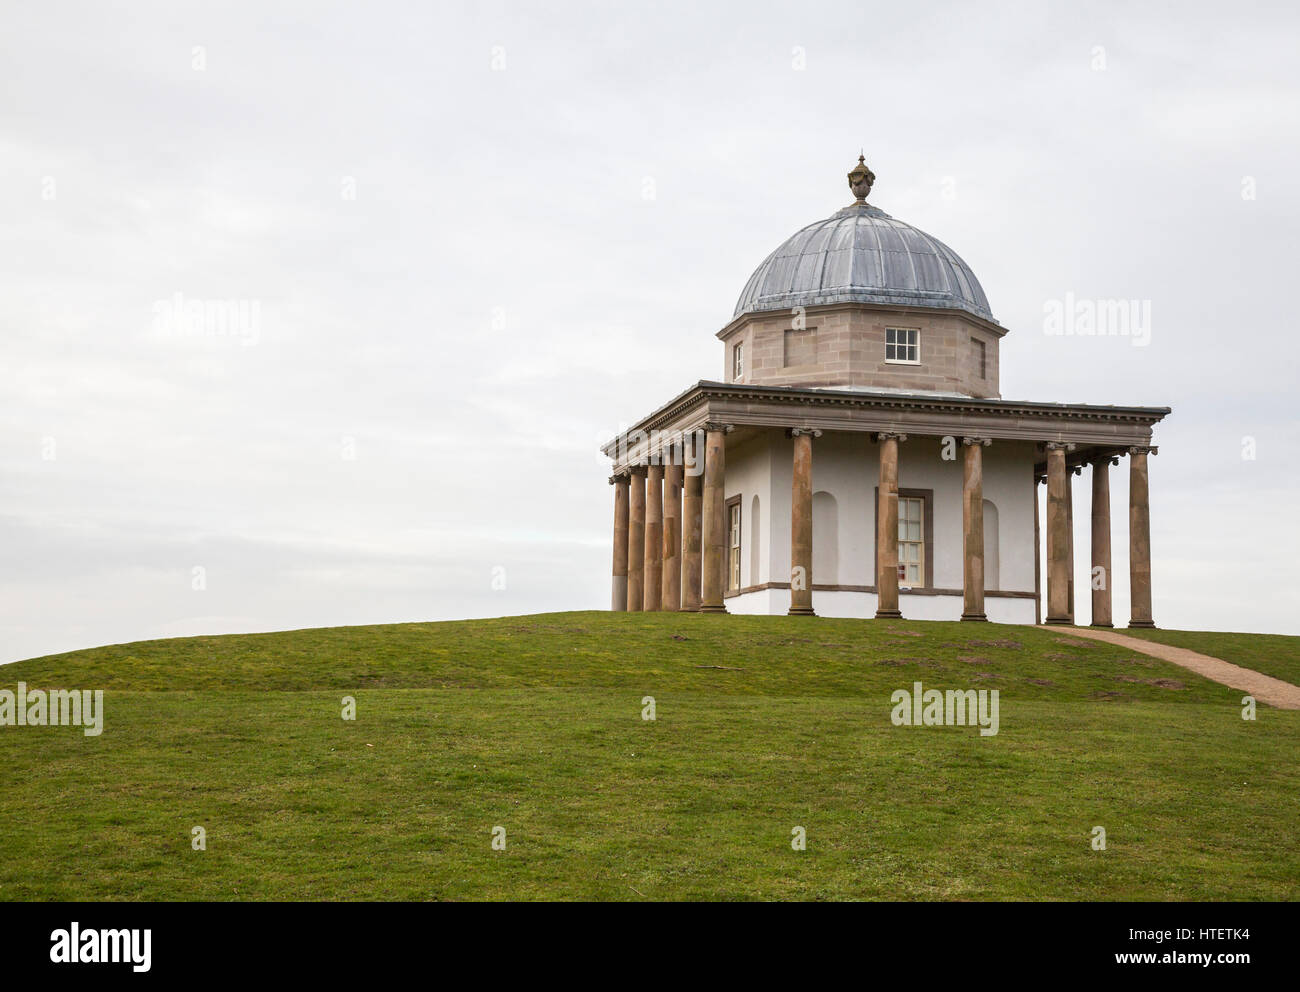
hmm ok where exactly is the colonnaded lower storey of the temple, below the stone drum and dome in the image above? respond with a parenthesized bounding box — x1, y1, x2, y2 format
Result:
(605, 382, 1167, 625)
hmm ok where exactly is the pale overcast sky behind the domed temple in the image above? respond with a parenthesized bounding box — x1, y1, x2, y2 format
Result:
(0, 0, 1300, 660)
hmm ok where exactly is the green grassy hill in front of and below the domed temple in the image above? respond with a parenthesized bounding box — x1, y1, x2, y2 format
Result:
(0, 612, 1300, 900)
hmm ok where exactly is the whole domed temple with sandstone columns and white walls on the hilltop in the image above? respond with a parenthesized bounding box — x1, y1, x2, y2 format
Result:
(602, 157, 1170, 627)
